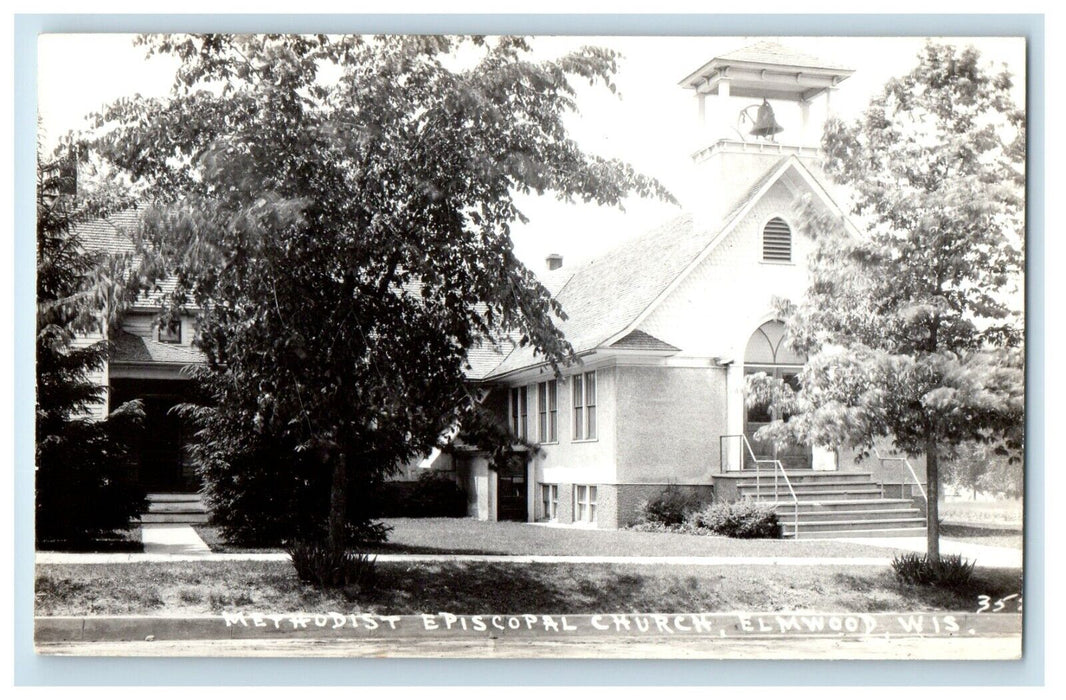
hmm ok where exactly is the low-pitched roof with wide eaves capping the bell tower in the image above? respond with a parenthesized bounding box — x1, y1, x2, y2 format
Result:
(678, 40, 855, 101)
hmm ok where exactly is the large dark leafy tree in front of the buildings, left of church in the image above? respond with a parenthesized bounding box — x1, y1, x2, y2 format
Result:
(95, 35, 665, 551)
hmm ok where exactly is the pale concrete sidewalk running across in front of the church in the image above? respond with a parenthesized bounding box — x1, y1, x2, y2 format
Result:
(36, 525, 1021, 569)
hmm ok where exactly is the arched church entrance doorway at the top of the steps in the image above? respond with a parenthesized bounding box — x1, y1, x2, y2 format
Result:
(744, 321, 811, 469)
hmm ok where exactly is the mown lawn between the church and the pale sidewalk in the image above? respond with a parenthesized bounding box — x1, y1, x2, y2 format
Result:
(197, 518, 908, 557)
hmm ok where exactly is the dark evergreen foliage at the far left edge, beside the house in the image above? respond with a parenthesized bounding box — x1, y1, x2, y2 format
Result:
(35, 141, 147, 547)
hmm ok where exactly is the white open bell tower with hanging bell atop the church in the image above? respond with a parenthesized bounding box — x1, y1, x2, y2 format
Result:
(678, 42, 854, 216)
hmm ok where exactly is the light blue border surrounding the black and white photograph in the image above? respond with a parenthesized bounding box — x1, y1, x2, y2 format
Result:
(14, 15, 1045, 685)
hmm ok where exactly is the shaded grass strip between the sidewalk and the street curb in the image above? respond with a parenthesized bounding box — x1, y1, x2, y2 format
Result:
(35, 561, 1021, 615)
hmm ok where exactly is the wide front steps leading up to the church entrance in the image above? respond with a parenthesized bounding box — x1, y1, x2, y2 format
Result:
(724, 471, 925, 539)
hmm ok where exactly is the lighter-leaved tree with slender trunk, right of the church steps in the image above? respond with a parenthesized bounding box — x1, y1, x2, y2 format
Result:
(753, 44, 1024, 558)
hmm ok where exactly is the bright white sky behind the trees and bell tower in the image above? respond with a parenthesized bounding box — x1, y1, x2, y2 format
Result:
(38, 34, 1024, 270)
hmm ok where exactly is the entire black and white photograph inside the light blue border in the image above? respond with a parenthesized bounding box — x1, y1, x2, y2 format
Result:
(33, 30, 1027, 661)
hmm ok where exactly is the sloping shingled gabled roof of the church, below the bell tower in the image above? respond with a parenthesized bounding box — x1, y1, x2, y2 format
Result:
(486, 156, 839, 378)
